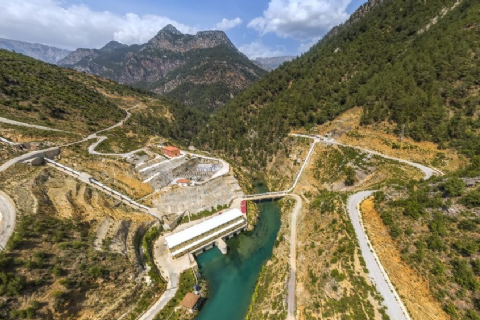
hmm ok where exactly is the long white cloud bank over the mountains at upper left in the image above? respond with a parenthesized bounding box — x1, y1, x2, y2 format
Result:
(0, 0, 197, 49)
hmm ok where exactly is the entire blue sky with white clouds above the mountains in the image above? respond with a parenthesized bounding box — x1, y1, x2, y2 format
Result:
(0, 0, 366, 58)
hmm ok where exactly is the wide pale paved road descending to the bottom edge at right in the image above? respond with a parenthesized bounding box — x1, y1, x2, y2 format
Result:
(347, 191, 410, 320)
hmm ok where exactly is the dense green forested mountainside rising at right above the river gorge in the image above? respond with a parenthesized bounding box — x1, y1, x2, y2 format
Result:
(198, 0, 480, 166)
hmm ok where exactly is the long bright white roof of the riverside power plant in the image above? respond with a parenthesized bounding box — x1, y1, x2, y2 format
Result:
(165, 209, 243, 248)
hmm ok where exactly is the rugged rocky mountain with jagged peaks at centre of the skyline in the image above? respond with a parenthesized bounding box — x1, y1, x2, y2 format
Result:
(59, 25, 265, 110)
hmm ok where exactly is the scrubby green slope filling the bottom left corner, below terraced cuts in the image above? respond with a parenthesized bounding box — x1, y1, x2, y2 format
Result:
(0, 214, 142, 319)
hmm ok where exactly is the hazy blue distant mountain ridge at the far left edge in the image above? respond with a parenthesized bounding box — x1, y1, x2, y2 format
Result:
(0, 38, 71, 64)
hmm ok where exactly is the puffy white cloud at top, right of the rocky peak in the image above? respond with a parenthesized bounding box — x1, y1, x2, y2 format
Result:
(248, 0, 352, 41)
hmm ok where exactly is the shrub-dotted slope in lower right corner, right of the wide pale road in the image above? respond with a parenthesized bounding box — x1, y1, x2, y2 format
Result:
(375, 158, 480, 319)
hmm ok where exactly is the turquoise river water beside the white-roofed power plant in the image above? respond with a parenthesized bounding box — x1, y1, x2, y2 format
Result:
(195, 185, 280, 320)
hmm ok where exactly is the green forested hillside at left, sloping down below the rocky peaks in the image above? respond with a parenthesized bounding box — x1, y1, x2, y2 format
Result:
(0, 50, 205, 139)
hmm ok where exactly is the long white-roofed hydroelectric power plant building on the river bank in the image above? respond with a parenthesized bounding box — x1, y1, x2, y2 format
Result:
(165, 209, 247, 258)
